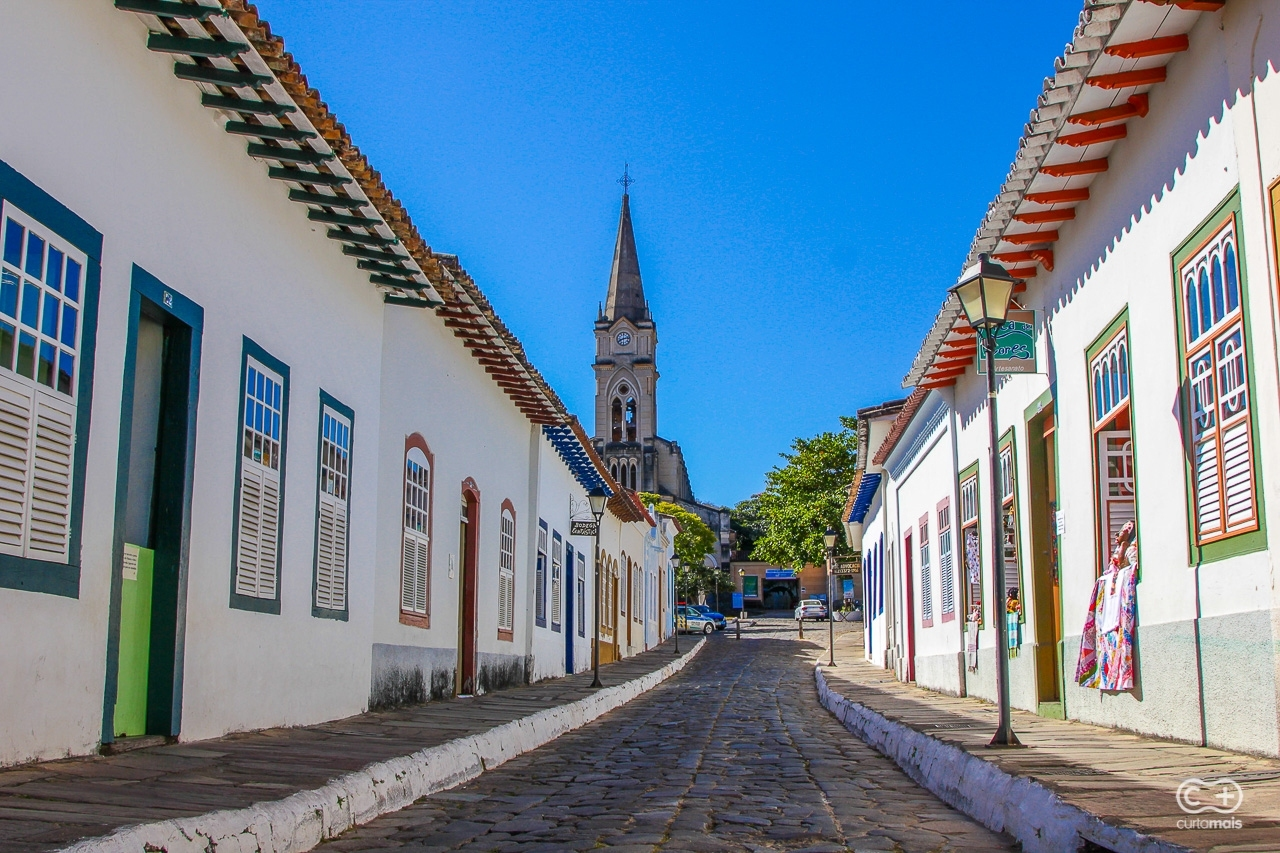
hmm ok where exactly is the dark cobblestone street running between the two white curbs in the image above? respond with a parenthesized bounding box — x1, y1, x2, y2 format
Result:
(319, 620, 1016, 853)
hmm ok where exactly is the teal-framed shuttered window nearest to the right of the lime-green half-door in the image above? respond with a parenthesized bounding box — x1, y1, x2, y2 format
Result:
(230, 337, 289, 615)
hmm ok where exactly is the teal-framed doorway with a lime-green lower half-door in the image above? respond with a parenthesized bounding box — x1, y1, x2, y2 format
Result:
(102, 268, 204, 745)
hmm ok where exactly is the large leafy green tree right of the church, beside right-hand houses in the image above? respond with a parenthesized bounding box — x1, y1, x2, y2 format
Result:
(749, 418, 858, 569)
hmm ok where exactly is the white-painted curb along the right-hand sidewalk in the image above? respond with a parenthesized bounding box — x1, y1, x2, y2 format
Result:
(814, 666, 1189, 853)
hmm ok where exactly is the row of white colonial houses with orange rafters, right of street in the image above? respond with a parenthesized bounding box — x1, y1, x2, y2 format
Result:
(863, 0, 1280, 754)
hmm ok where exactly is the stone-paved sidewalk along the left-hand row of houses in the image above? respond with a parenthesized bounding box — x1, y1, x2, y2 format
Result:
(0, 638, 696, 853)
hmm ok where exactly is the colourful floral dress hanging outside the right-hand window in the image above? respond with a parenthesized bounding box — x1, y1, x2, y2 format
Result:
(1075, 544, 1138, 690)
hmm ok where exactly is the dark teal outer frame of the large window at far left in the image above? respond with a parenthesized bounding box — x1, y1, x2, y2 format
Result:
(0, 160, 102, 598)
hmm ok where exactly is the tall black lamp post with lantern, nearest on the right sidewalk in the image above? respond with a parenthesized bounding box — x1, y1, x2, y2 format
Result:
(951, 254, 1021, 747)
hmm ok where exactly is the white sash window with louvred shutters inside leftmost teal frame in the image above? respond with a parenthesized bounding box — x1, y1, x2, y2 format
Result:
(0, 202, 88, 562)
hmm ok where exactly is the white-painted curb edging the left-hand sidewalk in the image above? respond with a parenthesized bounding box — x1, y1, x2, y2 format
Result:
(65, 640, 707, 853)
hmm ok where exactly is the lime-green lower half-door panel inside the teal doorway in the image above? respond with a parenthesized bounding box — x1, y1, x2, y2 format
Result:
(115, 543, 155, 738)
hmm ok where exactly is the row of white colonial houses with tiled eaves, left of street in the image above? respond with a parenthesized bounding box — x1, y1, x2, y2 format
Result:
(0, 0, 671, 765)
